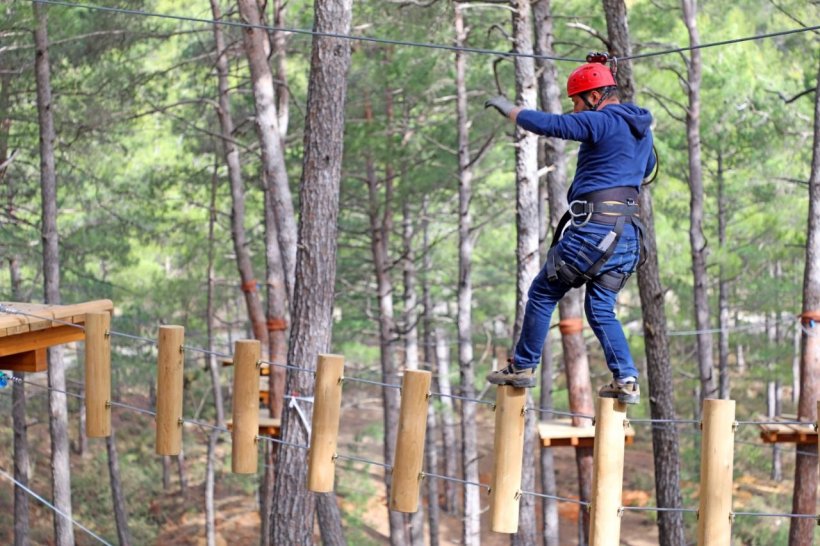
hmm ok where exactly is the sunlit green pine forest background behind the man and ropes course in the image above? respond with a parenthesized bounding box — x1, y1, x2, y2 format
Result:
(0, 0, 820, 545)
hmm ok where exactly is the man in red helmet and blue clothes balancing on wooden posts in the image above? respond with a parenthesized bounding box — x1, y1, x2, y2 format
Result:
(484, 54, 657, 404)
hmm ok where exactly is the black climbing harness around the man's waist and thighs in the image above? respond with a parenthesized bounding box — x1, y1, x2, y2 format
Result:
(546, 187, 646, 292)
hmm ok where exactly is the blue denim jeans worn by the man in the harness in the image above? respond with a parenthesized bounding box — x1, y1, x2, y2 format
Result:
(514, 218, 640, 380)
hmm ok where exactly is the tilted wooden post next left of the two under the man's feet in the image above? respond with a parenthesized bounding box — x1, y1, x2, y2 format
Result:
(390, 370, 432, 512)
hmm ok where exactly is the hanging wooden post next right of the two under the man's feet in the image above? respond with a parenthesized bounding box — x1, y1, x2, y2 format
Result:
(698, 399, 735, 546)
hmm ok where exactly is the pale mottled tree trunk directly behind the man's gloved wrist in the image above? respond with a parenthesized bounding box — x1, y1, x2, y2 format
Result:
(511, 0, 540, 546)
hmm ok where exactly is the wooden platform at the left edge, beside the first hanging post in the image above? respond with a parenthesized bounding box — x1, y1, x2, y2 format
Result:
(0, 300, 114, 372)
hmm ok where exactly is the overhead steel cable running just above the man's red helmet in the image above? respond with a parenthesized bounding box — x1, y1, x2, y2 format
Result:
(32, 0, 820, 63)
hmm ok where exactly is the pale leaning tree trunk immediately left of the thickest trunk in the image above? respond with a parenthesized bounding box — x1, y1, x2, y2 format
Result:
(237, 0, 296, 301)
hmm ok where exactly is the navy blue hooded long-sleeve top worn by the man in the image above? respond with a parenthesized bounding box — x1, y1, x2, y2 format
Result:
(516, 103, 656, 201)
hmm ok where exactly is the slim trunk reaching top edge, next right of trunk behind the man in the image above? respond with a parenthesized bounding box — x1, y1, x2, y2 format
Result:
(681, 0, 717, 401)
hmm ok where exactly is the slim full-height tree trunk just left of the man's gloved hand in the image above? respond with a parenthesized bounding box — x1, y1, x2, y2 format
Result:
(453, 2, 481, 545)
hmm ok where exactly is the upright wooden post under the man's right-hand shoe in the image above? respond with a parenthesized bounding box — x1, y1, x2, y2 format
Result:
(589, 397, 626, 546)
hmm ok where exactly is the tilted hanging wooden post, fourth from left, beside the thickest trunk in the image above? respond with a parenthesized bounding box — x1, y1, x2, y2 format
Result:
(308, 355, 345, 493)
